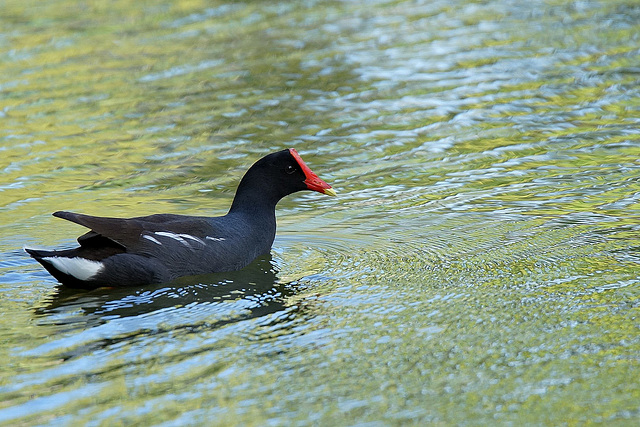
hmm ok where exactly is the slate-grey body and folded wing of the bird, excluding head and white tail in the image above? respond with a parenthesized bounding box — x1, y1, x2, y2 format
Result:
(64, 211, 276, 286)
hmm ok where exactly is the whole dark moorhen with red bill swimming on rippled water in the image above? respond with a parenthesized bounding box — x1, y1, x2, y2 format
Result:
(24, 148, 336, 289)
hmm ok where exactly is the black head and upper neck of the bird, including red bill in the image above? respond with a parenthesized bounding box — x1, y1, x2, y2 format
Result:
(231, 148, 336, 210)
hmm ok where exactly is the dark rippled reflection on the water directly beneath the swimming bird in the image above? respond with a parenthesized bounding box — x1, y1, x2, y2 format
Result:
(36, 254, 302, 326)
